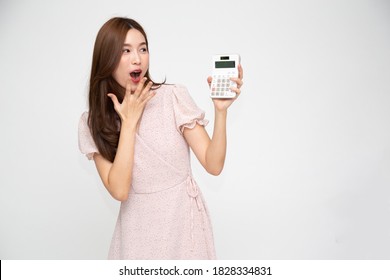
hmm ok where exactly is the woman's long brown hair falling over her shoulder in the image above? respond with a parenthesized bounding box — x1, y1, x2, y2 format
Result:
(88, 17, 165, 162)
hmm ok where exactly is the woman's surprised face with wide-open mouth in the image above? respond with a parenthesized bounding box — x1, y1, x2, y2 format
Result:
(113, 28, 149, 92)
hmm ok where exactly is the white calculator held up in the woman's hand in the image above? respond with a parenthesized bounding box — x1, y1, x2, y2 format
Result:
(210, 54, 240, 98)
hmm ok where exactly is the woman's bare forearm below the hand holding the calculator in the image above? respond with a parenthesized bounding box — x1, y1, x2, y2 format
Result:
(206, 109, 227, 175)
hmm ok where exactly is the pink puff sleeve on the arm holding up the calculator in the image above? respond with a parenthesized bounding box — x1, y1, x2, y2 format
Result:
(173, 85, 209, 134)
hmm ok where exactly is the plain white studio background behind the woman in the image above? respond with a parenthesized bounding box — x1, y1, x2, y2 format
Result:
(0, 0, 390, 259)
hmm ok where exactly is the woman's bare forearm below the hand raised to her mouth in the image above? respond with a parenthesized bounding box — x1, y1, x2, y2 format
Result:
(108, 124, 136, 201)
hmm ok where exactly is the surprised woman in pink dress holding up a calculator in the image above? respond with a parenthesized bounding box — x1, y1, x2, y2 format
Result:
(79, 18, 242, 259)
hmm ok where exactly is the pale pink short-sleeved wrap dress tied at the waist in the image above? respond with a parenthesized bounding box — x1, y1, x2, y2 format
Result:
(79, 85, 216, 259)
